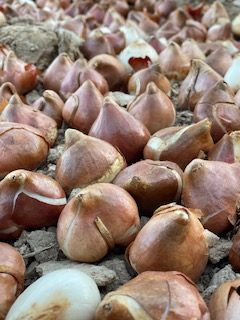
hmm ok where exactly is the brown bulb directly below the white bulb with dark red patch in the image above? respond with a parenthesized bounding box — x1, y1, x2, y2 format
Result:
(128, 64, 171, 95)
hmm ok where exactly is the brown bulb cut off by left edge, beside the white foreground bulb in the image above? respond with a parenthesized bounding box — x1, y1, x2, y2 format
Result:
(0, 242, 26, 320)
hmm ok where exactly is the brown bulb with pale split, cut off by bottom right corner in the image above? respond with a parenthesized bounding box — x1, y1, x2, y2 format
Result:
(209, 279, 240, 320)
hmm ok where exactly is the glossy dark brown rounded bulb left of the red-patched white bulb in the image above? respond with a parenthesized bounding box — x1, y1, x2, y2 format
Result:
(89, 54, 128, 91)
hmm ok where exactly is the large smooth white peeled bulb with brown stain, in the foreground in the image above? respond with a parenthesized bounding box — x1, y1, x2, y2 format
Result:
(6, 269, 101, 320)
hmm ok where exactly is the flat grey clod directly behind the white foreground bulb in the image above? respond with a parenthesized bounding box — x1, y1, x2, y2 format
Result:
(36, 260, 116, 287)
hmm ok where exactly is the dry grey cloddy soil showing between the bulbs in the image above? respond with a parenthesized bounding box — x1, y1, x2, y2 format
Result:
(0, 1, 240, 312)
